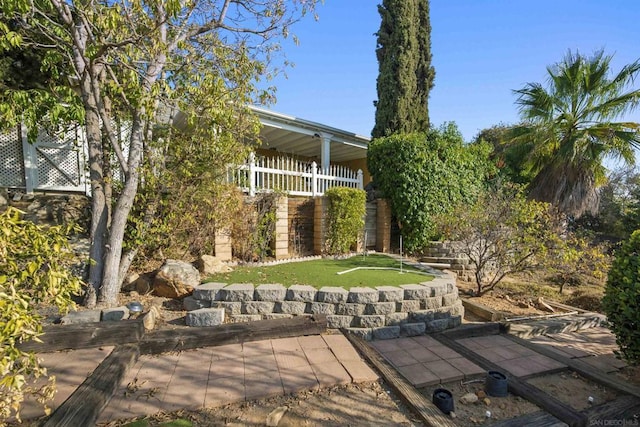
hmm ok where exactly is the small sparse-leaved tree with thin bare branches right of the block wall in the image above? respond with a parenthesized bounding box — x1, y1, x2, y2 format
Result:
(438, 187, 558, 296)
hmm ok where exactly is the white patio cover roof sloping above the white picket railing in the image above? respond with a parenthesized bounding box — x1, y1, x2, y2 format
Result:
(251, 107, 370, 162)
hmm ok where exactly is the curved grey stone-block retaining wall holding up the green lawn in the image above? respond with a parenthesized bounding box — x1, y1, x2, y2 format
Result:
(183, 275, 464, 340)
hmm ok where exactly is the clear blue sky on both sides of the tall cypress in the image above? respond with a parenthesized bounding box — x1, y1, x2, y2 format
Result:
(270, 0, 640, 141)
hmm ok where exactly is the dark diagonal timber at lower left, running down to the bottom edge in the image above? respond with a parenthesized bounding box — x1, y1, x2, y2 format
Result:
(44, 344, 140, 427)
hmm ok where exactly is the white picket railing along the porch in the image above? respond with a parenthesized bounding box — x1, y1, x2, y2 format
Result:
(229, 153, 363, 196)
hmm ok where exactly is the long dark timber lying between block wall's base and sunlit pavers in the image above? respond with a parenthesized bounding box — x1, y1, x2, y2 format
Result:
(139, 314, 327, 354)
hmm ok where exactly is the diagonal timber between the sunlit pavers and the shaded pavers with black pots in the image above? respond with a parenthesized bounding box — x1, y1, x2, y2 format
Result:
(343, 331, 456, 427)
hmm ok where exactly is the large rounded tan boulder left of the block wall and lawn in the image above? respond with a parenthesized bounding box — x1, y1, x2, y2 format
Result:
(153, 259, 200, 298)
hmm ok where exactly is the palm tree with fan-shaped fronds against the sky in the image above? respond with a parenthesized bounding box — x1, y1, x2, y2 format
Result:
(513, 50, 640, 217)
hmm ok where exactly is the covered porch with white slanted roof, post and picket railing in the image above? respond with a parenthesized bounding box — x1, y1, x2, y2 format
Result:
(238, 107, 371, 197)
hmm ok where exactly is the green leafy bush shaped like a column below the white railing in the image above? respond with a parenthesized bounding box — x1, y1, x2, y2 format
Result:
(325, 187, 367, 255)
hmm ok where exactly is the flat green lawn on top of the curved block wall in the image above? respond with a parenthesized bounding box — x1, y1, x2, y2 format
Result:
(207, 255, 433, 289)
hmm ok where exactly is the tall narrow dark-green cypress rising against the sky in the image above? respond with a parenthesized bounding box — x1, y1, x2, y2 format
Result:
(372, 0, 435, 138)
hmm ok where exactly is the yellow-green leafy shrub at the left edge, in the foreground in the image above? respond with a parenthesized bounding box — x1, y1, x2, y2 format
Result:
(0, 208, 81, 424)
